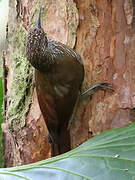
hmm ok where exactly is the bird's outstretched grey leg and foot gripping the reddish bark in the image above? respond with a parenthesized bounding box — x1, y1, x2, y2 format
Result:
(81, 82, 114, 96)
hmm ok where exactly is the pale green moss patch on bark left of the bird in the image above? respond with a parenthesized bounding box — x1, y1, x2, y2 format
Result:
(7, 26, 33, 131)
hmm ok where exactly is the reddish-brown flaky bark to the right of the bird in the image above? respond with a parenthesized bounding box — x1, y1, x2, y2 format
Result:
(71, 0, 135, 147)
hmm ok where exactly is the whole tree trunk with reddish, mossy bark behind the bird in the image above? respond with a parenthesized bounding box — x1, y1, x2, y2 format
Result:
(2, 0, 135, 167)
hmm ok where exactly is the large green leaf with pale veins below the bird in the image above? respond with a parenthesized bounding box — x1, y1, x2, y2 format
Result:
(0, 123, 135, 180)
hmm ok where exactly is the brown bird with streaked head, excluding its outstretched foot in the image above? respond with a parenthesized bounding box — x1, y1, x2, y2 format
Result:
(26, 8, 84, 155)
